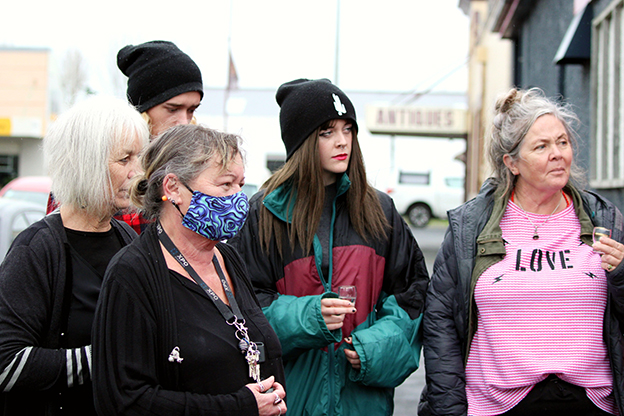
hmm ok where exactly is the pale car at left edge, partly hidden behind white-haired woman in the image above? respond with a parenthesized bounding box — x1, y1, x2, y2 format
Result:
(0, 198, 46, 262)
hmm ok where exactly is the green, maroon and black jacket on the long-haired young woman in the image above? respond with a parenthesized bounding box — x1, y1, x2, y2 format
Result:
(229, 174, 429, 415)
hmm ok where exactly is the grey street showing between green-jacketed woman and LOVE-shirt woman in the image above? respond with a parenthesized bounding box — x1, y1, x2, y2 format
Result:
(394, 222, 446, 416)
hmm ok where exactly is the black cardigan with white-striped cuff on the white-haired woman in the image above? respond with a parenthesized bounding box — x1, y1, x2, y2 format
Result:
(0, 213, 136, 416)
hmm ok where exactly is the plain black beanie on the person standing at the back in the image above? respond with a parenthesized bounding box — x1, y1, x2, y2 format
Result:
(117, 40, 204, 113)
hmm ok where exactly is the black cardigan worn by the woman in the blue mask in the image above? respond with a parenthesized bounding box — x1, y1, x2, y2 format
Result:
(93, 224, 284, 416)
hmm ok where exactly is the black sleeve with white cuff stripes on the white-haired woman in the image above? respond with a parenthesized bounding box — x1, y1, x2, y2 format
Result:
(0, 226, 90, 392)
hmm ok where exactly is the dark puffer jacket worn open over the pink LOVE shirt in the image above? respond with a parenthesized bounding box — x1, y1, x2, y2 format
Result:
(418, 180, 624, 416)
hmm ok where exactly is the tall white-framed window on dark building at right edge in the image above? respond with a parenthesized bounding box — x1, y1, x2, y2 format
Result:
(590, 0, 624, 188)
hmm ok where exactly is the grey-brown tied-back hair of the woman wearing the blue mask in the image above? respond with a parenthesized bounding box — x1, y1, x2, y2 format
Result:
(130, 124, 243, 219)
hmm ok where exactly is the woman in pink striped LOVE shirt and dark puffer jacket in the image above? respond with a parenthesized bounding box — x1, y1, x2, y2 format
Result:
(419, 89, 624, 416)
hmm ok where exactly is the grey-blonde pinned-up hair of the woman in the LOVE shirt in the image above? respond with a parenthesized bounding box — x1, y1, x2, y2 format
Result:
(488, 88, 585, 195)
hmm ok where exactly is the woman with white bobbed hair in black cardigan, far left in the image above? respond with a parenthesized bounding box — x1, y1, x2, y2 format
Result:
(0, 97, 149, 415)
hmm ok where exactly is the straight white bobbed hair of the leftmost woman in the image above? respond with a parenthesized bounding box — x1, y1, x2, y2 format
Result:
(43, 96, 149, 215)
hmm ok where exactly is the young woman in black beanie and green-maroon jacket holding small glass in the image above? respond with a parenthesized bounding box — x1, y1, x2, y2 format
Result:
(229, 79, 428, 416)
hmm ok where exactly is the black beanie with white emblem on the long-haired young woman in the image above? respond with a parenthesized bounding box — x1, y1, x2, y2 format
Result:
(275, 78, 357, 160)
